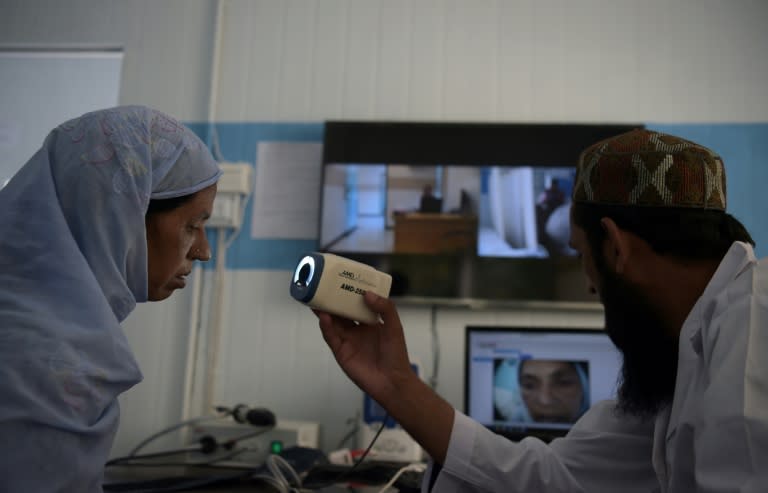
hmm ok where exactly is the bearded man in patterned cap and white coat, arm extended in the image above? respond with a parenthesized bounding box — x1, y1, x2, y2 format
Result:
(316, 130, 768, 493)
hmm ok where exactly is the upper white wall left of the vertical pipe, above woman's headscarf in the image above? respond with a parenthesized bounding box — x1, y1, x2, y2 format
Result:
(0, 0, 215, 121)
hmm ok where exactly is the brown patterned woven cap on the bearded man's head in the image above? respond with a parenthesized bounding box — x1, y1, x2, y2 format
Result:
(573, 129, 726, 210)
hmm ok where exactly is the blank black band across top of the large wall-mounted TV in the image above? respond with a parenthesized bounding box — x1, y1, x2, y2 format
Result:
(323, 120, 645, 167)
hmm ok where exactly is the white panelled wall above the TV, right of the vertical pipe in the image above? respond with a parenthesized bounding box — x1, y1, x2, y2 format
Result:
(217, 0, 768, 122)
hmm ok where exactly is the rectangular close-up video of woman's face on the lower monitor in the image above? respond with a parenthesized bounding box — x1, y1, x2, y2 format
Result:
(493, 358, 589, 423)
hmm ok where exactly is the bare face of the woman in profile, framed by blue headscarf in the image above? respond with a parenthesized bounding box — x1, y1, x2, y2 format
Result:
(145, 184, 216, 301)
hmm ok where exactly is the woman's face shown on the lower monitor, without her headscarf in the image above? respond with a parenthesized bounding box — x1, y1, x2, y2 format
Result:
(520, 360, 584, 422)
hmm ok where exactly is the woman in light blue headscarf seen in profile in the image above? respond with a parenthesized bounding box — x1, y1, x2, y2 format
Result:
(0, 106, 221, 493)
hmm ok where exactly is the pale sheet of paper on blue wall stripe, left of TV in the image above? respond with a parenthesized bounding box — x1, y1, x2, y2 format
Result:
(251, 142, 323, 239)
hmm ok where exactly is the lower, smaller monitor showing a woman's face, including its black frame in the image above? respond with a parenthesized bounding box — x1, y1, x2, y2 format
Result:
(464, 326, 621, 441)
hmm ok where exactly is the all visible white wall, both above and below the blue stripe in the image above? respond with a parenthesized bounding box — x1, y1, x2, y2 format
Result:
(0, 0, 768, 453)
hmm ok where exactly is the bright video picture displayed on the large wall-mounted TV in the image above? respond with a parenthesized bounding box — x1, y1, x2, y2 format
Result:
(320, 163, 575, 258)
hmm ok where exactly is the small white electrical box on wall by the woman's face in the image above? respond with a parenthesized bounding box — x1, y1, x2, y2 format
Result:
(207, 163, 253, 229)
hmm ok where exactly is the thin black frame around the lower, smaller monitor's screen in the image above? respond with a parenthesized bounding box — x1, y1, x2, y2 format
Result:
(462, 325, 608, 442)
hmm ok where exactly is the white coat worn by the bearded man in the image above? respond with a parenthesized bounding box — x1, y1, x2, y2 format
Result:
(423, 242, 768, 493)
